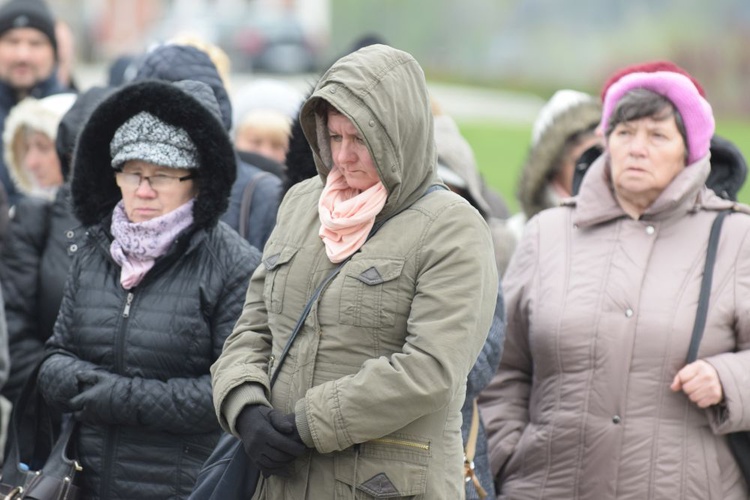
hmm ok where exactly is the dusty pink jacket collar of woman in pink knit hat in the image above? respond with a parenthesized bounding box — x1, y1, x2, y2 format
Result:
(563, 153, 711, 227)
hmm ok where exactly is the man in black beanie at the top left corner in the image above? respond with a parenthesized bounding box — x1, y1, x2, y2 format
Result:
(0, 0, 67, 206)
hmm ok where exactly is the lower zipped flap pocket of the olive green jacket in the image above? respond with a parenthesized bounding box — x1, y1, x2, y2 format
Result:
(334, 434, 430, 500)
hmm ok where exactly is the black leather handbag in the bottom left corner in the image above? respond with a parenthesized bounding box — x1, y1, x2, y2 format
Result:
(0, 363, 83, 500)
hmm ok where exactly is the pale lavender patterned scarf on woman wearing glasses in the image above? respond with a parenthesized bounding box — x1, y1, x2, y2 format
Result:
(109, 199, 195, 290)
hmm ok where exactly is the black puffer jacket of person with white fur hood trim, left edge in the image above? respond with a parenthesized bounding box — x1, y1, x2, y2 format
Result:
(0, 87, 110, 406)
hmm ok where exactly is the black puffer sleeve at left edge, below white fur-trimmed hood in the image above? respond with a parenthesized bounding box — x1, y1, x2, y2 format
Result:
(0, 198, 51, 401)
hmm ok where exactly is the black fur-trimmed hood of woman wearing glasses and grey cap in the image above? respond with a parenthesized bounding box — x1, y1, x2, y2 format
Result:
(71, 80, 237, 228)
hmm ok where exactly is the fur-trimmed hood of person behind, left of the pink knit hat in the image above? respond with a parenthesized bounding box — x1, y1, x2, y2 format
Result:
(517, 96, 602, 219)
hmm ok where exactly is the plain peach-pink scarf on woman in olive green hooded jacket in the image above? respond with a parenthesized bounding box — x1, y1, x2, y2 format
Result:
(318, 167, 388, 264)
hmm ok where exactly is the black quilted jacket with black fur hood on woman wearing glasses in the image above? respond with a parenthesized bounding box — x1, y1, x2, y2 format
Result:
(39, 81, 260, 500)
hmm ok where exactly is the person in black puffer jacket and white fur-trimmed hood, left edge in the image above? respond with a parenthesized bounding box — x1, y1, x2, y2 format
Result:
(0, 87, 108, 457)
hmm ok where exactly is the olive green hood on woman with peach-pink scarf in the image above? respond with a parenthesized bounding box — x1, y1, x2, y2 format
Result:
(300, 45, 440, 217)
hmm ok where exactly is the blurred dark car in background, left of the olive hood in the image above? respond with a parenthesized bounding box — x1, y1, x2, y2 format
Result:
(229, 13, 321, 74)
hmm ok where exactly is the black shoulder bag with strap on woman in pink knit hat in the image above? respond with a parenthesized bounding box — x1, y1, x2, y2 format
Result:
(686, 210, 750, 485)
